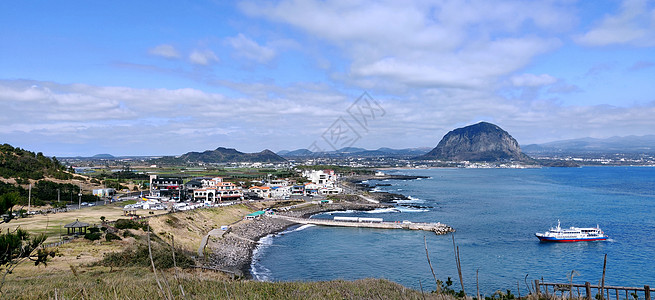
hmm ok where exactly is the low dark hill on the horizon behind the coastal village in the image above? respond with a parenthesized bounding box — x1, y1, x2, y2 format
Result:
(179, 147, 286, 163)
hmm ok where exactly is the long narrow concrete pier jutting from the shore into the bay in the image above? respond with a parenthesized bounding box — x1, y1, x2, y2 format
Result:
(268, 215, 455, 234)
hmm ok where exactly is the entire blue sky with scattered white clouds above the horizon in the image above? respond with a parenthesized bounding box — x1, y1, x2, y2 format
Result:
(0, 0, 655, 156)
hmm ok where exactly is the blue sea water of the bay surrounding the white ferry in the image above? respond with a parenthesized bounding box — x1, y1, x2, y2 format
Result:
(252, 167, 655, 295)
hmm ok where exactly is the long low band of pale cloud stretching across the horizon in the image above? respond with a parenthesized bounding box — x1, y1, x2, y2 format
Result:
(0, 76, 655, 155)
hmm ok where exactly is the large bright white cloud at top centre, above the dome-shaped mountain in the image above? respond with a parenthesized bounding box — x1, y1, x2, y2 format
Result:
(241, 0, 575, 87)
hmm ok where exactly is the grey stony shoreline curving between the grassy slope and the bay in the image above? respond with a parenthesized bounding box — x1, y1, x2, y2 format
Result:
(205, 202, 389, 278)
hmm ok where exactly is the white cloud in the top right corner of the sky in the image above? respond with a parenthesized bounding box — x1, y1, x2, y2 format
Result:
(575, 0, 655, 47)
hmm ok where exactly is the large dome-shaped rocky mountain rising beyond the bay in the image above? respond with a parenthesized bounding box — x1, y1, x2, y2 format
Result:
(417, 122, 532, 162)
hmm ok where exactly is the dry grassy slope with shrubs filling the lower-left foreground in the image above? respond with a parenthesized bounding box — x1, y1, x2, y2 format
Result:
(0, 211, 451, 300)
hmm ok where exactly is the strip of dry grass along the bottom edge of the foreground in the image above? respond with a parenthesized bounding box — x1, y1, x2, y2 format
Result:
(2, 267, 444, 300)
